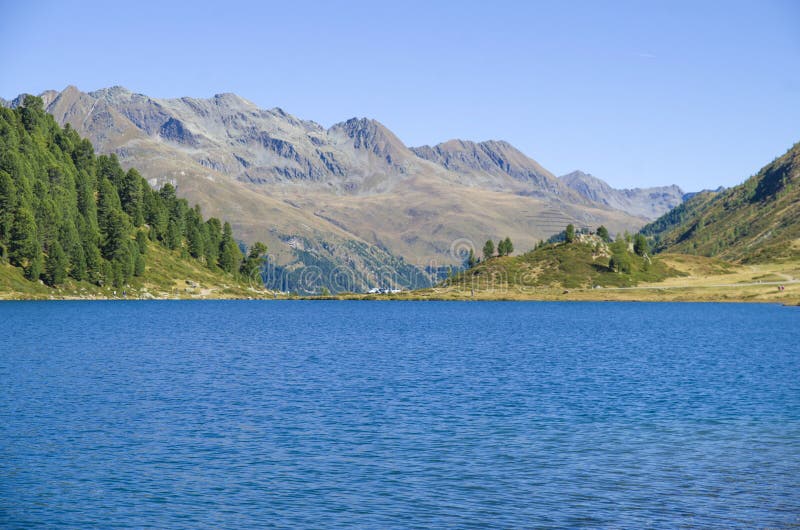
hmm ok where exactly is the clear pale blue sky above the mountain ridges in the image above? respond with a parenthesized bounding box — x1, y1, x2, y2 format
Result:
(0, 0, 800, 190)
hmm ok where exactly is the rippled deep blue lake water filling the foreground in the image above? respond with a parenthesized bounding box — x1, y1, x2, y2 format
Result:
(0, 301, 800, 528)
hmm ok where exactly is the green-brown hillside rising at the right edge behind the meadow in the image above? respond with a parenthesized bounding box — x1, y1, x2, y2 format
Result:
(642, 143, 800, 262)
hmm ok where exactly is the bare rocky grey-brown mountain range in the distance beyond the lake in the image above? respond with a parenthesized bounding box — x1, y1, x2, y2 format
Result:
(5, 86, 683, 291)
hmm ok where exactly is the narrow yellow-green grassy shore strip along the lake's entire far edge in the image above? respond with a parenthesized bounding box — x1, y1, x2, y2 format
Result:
(0, 252, 800, 305)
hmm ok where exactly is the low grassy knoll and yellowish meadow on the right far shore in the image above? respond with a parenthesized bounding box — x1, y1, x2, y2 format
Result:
(328, 245, 800, 305)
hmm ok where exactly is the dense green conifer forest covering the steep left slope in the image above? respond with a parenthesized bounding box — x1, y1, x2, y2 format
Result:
(0, 96, 266, 287)
